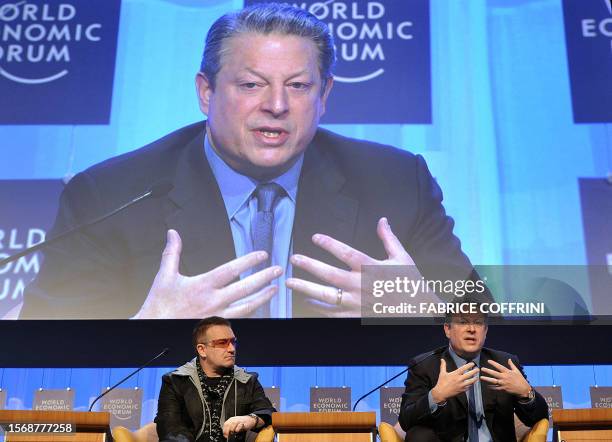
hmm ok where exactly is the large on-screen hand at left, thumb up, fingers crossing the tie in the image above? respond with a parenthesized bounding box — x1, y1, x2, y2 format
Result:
(133, 230, 283, 319)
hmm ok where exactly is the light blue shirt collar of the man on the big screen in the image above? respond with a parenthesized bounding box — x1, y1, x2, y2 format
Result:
(204, 134, 304, 219)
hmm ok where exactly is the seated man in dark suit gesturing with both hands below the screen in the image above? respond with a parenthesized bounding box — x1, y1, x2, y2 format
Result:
(399, 303, 548, 442)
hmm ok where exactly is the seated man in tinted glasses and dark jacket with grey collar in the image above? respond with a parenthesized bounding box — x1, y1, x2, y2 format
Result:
(155, 316, 276, 442)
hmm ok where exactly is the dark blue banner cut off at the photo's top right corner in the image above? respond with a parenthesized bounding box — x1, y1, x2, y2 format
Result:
(563, 0, 612, 123)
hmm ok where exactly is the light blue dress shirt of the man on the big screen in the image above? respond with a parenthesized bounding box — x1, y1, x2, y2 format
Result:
(204, 136, 304, 318)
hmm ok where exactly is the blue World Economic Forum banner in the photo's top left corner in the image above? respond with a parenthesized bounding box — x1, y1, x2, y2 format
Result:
(0, 0, 120, 124)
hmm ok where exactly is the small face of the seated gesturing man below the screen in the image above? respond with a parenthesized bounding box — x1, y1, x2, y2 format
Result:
(444, 314, 488, 358)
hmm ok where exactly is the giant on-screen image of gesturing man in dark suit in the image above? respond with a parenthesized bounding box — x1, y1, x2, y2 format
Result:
(21, 3, 470, 318)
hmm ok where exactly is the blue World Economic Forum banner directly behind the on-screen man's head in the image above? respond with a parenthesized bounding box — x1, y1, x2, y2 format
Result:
(245, 0, 431, 124)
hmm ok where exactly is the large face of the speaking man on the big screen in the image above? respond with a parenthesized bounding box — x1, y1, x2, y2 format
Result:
(196, 33, 332, 180)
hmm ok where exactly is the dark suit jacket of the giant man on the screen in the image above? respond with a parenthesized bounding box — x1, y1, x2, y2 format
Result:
(21, 123, 470, 318)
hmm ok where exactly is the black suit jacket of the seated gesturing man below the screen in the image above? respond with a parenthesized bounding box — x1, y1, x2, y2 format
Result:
(399, 348, 548, 442)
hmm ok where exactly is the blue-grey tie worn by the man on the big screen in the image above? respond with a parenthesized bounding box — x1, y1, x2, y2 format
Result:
(251, 183, 285, 318)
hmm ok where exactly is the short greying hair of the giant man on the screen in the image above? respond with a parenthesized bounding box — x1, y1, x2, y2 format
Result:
(200, 3, 336, 92)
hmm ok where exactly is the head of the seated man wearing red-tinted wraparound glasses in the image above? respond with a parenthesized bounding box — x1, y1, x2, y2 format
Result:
(198, 325, 236, 373)
